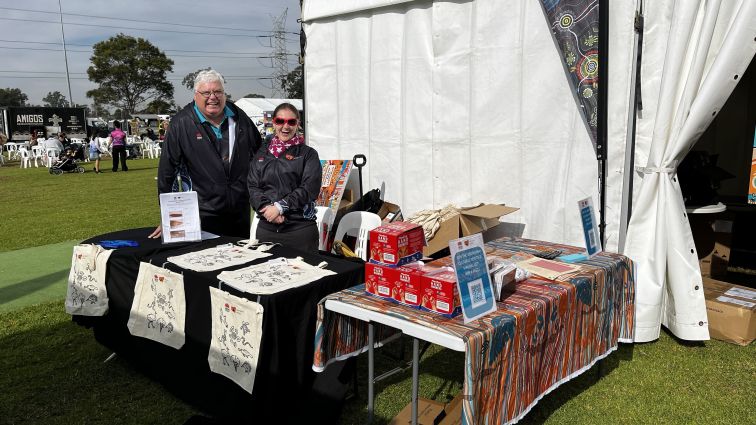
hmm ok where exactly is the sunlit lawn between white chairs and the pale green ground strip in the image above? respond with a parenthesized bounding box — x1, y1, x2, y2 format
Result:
(0, 158, 160, 252)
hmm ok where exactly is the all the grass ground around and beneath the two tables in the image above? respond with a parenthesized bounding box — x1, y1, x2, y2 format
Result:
(0, 154, 756, 424)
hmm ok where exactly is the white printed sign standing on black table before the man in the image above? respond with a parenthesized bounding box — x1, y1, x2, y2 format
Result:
(160, 191, 202, 243)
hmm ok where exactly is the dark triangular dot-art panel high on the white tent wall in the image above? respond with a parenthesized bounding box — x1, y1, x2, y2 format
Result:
(541, 0, 599, 151)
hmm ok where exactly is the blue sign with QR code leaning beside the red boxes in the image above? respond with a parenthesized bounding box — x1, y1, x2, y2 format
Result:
(449, 233, 496, 323)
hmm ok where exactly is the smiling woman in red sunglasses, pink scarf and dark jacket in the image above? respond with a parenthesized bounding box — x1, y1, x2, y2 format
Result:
(247, 103, 322, 252)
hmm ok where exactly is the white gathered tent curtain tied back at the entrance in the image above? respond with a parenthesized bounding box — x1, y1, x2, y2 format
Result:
(624, 0, 756, 342)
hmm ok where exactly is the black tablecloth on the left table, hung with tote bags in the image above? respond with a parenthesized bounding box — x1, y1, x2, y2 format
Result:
(73, 228, 363, 423)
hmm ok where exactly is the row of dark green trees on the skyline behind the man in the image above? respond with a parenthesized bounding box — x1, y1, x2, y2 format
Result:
(0, 34, 304, 118)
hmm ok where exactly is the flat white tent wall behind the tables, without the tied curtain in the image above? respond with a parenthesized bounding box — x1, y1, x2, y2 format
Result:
(303, 0, 634, 248)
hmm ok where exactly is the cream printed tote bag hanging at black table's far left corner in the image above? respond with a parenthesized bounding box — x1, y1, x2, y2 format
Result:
(66, 245, 113, 316)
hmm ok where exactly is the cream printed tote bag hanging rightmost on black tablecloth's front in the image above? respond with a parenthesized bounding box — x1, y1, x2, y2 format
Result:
(207, 287, 263, 394)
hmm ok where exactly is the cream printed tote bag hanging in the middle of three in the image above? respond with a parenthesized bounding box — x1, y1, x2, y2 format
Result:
(126, 262, 186, 350)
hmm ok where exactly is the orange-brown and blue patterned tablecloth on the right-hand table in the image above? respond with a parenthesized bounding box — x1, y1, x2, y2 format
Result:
(313, 238, 635, 424)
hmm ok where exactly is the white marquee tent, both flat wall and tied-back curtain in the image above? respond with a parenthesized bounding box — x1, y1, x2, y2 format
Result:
(302, 0, 756, 341)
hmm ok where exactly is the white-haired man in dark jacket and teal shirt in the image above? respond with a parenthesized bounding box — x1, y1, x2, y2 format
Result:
(150, 70, 262, 238)
